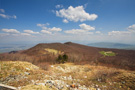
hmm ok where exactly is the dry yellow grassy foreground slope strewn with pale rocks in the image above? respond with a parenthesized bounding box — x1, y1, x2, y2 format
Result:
(0, 61, 135, 90)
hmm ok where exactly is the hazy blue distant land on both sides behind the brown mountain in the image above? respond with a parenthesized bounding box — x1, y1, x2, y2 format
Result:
(0, 42, 135, 53)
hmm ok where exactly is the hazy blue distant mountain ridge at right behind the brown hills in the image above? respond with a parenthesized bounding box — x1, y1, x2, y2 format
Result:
(88, 42, 135, 50)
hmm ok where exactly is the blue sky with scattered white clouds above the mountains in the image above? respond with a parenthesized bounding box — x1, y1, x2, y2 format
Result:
(0, 0, 135, 44)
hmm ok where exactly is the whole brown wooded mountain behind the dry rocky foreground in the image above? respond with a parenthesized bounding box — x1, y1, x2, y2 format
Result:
(0, 42, 135, 70)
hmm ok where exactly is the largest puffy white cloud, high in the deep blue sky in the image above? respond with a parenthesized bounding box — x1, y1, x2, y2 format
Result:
(56, 6, 98, 22)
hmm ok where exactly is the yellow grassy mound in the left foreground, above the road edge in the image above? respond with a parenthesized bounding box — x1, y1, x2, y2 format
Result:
(0, 61, 45, 87)
